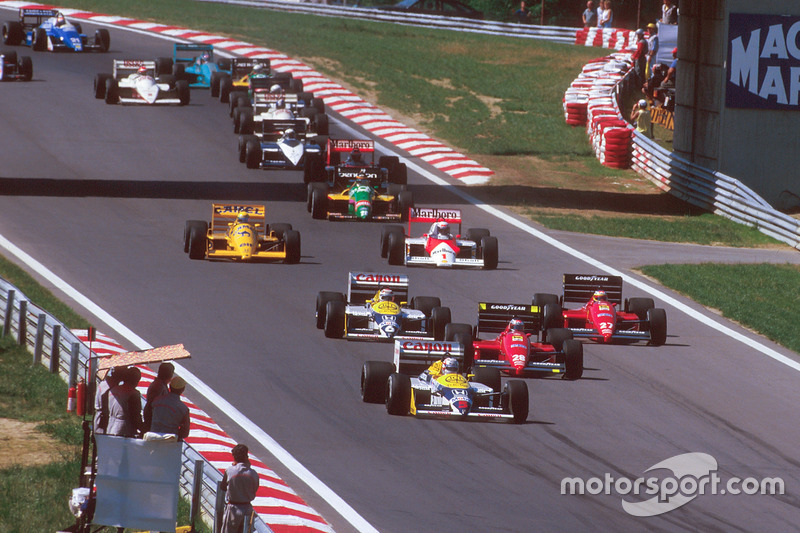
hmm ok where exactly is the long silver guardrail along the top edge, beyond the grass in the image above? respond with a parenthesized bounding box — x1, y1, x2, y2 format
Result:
(197, 0, 578, 44)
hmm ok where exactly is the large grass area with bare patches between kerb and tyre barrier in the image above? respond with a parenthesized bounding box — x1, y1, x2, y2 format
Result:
(48, 0, 778, 246)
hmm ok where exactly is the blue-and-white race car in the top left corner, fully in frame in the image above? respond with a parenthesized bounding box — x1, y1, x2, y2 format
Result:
(3, 8, 111, 52)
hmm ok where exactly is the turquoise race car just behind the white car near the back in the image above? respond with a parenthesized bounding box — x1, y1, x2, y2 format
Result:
(156, 43, 231, 88)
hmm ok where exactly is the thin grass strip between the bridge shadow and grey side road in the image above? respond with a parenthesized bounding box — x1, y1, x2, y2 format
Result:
(527, 210, 781, 247)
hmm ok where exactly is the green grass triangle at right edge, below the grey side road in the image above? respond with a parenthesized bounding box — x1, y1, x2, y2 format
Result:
(641, 263, 800, 352)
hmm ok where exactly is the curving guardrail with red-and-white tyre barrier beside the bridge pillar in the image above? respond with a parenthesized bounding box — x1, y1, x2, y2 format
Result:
(564, 53, 800, 249)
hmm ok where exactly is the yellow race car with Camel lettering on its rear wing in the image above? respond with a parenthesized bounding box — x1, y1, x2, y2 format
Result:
(183, 204, 300, 263)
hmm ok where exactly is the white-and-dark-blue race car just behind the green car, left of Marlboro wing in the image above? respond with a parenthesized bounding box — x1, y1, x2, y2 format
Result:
(239, 119, 327, 169)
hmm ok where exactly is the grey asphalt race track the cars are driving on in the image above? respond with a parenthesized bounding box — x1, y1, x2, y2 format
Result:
(0, 11, 800, 532)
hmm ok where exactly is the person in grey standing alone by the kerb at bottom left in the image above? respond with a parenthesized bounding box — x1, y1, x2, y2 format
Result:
(220, 444, 259, 533)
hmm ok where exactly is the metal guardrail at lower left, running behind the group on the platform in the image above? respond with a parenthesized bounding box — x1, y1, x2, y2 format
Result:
(0, 278, 272, 533)
